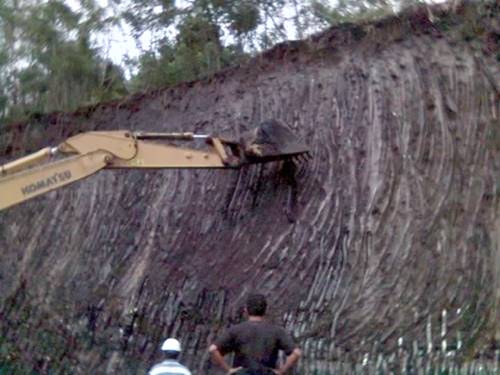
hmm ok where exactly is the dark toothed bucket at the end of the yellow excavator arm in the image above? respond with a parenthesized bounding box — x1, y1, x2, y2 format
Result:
(233, 120, 309, 163)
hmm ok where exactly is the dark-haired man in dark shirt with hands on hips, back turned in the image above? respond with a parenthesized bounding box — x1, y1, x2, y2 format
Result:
(208, 294, 301, 375)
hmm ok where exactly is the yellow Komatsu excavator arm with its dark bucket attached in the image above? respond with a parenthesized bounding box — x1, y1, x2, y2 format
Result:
(0, 120, 308, 210)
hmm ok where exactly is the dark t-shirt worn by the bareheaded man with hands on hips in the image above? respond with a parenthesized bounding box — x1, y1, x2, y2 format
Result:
(215, 321, 295, 369)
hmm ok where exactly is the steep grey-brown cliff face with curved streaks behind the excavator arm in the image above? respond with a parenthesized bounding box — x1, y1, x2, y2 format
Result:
(0, 1, 500, 374)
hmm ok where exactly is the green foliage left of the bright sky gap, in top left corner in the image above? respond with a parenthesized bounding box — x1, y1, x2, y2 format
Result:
(0, 0, 124, 122)
